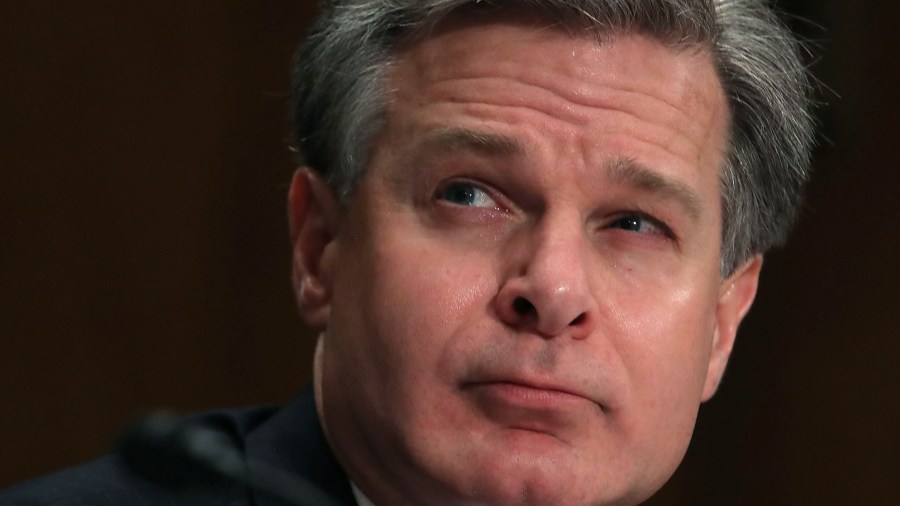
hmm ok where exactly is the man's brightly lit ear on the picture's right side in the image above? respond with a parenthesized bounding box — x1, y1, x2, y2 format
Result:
(701, 255, 762, 402)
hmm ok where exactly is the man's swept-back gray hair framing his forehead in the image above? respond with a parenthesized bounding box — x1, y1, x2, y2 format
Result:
(291, 0, 814, 276)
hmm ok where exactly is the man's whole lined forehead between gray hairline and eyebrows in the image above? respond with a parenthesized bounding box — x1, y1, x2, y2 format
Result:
(387, 11, 729, 194)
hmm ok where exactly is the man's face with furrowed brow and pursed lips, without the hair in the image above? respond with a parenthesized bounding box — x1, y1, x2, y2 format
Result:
(294, 10, 759, 505)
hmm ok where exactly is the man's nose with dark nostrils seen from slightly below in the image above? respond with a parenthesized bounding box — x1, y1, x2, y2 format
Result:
(496, 217, 598, 339)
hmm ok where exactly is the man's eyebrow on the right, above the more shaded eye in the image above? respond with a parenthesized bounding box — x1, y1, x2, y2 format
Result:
(605, 159, 703, 221)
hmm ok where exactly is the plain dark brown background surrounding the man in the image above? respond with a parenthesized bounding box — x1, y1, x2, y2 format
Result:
(0, 0, 900, 505)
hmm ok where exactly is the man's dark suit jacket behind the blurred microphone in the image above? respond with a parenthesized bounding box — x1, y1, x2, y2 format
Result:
(0, 389, 356, 506)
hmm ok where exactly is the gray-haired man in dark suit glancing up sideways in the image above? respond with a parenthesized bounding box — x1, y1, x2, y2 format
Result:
(0, 0, 812, 506)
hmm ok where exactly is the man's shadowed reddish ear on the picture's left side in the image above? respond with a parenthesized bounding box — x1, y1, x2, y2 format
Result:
(288, 167, 340, 330)
